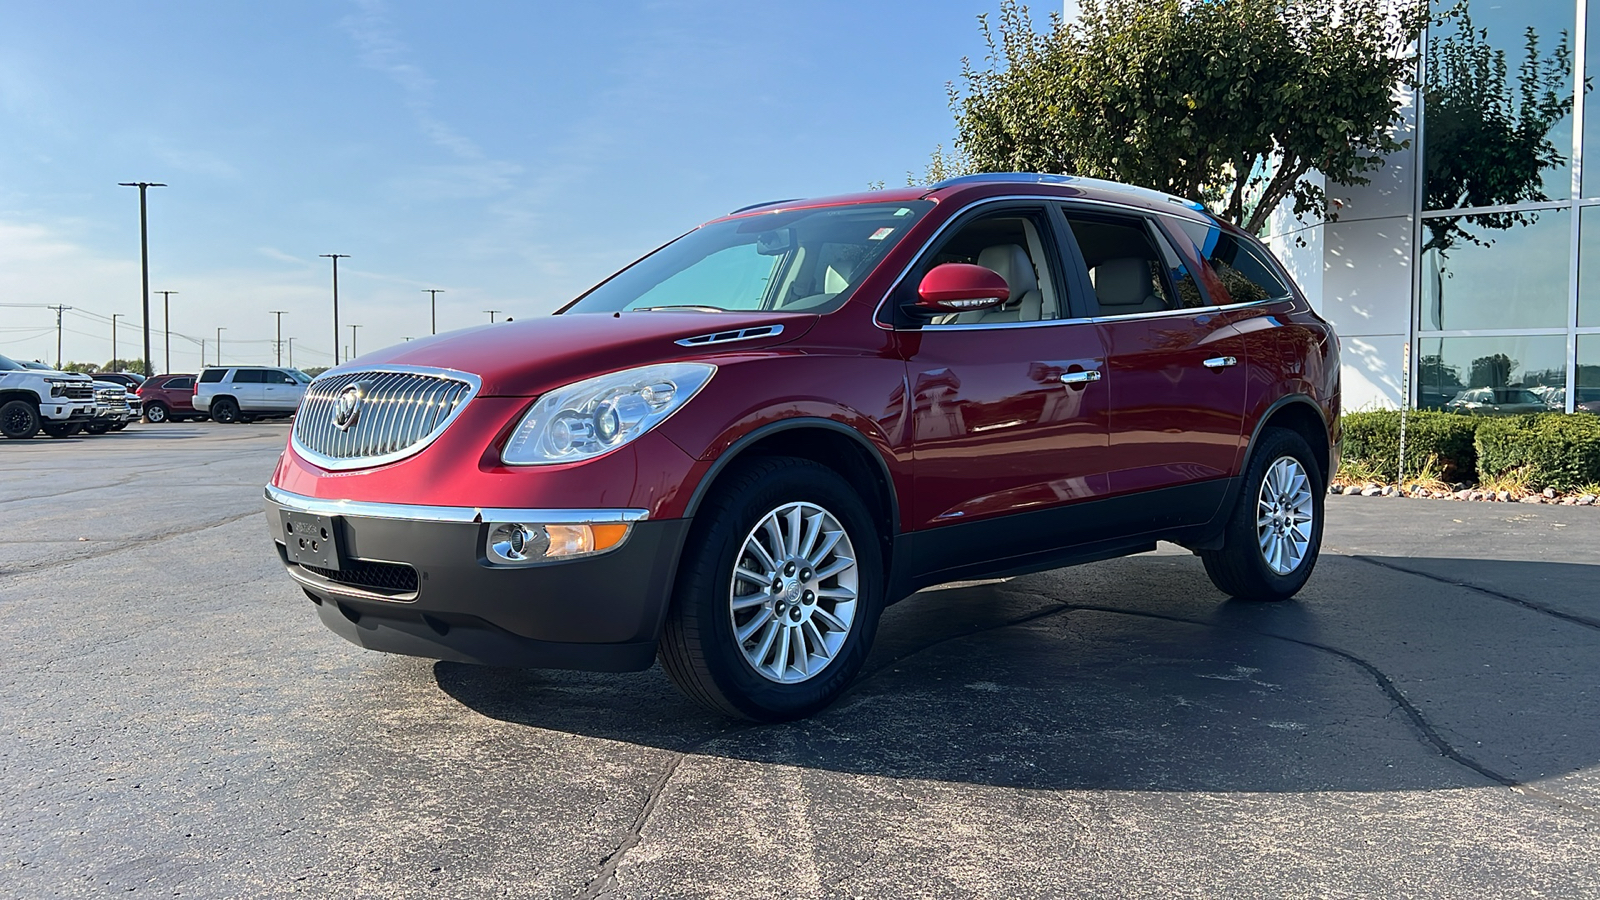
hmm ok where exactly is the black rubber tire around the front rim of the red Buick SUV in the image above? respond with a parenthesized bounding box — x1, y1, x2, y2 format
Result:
(659, 456, 883, 722)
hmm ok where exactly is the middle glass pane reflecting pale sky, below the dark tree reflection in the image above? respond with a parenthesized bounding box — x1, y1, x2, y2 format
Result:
(1422, 210, 1571, 331)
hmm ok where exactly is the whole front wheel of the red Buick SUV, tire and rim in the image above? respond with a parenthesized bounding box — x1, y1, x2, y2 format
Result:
(661, 456, 883, 722)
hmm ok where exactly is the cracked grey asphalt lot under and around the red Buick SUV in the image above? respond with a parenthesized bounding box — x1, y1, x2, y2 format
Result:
(0, 423, 1600, 898)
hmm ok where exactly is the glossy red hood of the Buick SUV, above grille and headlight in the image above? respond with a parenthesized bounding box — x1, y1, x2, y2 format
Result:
(328, 311, 818, 397)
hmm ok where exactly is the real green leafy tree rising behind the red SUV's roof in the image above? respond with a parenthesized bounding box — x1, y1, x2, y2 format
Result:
(950, 0, 1429, 232)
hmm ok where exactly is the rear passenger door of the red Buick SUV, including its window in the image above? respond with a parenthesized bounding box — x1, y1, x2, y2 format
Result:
(1061, 205, 1248, 530)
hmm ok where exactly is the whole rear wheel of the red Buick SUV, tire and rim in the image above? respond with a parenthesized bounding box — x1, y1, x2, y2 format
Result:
(1200, 428, 1326, 601)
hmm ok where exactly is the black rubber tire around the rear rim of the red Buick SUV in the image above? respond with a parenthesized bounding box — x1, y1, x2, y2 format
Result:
(1200, 428, 1328, 602)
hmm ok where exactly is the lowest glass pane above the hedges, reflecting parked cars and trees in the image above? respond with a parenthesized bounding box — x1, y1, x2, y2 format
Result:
(1416, 335, 1566, 415)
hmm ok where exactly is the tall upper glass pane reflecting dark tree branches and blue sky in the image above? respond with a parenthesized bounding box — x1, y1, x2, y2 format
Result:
(1422, 0, 1576, 208)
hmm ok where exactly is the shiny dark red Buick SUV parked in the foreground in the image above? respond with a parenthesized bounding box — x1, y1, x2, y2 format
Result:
(266, 175, 1339, 721)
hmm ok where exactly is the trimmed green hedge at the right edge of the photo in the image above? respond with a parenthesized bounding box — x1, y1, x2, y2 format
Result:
(1472, 413, 1600, 490)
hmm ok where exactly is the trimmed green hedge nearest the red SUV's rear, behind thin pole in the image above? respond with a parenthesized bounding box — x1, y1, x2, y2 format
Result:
(1344, 410, 1494, 482)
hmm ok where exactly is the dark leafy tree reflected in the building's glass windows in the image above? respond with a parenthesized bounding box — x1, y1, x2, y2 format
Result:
(1422, 11, 1573, 251)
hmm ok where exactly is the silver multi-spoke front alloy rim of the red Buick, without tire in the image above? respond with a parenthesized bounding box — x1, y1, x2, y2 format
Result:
(728, 503, 859, 684)
